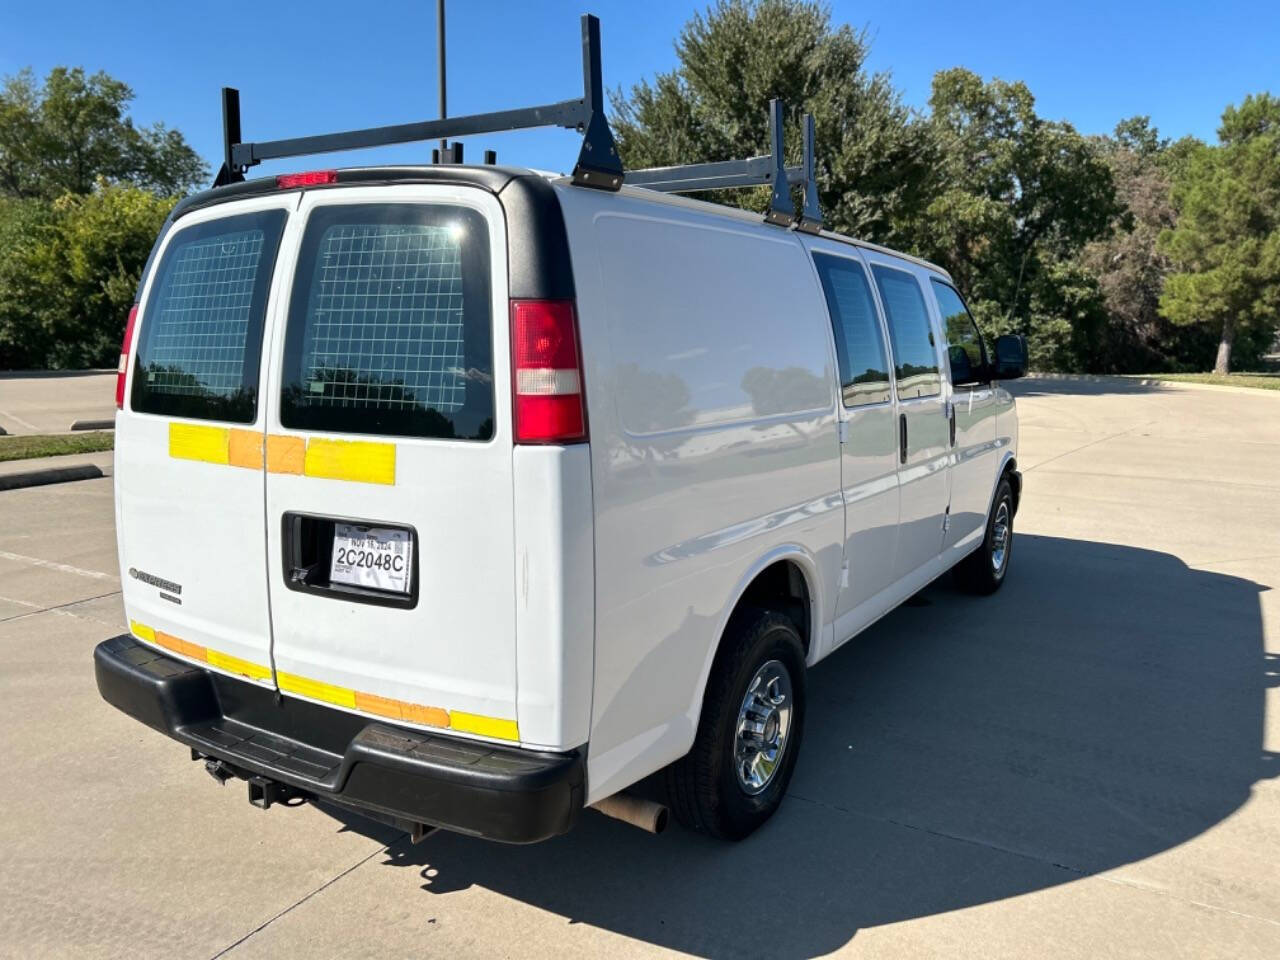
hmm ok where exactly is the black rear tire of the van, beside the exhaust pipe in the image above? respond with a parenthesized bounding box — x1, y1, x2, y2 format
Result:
(667, 609, 805, 840)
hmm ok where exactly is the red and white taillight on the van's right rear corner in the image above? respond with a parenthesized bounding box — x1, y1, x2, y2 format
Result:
(511, 300, 586, 443)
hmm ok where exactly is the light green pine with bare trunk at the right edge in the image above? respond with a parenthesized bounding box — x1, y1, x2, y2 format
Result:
(1160, 93, 1280, 374)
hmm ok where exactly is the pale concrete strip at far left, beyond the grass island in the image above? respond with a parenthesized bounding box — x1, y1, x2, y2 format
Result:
(0, 370, 115, 434)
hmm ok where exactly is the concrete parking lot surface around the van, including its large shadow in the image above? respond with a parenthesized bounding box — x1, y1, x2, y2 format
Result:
(0, 380, 1280, 960)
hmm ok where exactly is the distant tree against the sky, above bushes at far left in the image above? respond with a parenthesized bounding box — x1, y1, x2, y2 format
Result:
(0, 67, 209, 201)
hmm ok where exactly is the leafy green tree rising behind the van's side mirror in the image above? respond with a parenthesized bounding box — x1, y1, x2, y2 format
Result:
(914, 68, 1121, 369)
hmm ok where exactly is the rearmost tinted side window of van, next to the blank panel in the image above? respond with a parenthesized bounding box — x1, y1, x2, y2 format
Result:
(813, 253, 890, 407)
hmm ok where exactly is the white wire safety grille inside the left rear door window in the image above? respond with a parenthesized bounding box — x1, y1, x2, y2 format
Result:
(146, 230, 264, 397)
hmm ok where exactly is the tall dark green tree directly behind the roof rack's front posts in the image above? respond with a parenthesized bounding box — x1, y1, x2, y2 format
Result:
(612, 0, 933, 243)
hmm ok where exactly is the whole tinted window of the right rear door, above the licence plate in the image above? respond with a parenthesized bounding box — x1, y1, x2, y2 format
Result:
(280, 204, 494, 440)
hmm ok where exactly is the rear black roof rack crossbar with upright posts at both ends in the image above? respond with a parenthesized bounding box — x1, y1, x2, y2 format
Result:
(214, 14, 622, 189)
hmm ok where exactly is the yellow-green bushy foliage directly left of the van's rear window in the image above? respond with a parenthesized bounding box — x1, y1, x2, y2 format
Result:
(0, 183, 174, 369)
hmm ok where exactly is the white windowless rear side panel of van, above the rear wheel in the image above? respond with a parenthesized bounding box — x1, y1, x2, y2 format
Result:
(558, 187, 844, 801)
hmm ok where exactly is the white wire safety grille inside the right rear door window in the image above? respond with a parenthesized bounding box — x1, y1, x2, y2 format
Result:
(297, 224, 466, 412)
